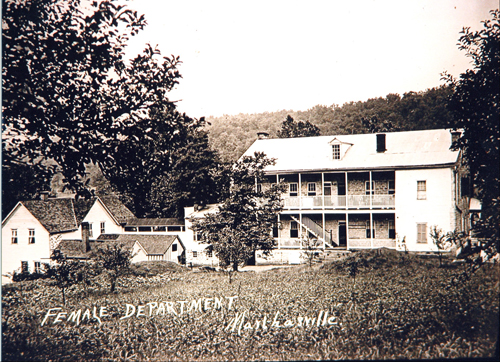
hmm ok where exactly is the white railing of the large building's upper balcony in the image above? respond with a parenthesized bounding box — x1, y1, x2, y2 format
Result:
(283, 194, 395, 210)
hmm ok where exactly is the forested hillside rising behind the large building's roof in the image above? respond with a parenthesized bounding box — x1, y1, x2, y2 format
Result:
(207, 86, 451, 161)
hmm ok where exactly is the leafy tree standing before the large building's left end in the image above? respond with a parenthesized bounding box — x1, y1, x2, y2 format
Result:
(193, 153, 282, 271)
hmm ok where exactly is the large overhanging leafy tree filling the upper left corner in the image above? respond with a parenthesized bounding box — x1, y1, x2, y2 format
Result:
(2, 0, 180, 199)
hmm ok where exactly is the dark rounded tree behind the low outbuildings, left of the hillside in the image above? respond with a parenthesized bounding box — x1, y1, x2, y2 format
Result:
(99, 103, 223, 217)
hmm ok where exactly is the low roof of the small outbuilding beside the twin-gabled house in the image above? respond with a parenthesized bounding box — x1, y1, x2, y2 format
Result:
(96, 234, 184, 255)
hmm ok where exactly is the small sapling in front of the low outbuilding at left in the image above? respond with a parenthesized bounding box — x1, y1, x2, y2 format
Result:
(92, 243, 133, 292)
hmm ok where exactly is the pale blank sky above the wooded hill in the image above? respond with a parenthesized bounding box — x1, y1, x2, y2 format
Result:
(128, 0, 498, 118)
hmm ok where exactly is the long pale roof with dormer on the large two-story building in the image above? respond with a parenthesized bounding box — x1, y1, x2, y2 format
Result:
(243, 129, 459, 174)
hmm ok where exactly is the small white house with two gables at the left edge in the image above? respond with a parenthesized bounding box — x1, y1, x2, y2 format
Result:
(2, 196, 134, 283)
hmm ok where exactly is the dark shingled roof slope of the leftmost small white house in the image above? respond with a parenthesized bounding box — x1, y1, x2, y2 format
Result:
(21, 199, 78, 234)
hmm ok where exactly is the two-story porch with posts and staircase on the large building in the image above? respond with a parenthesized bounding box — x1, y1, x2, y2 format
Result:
(267, 170, 396, 249)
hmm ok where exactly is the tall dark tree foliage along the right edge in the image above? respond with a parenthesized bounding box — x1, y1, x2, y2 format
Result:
(445, 9, 500, 268)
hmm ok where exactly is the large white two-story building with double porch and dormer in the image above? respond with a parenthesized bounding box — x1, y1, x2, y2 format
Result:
(186, 129, 472, 263)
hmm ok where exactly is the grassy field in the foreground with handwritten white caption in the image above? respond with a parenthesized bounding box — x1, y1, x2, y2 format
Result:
(2, 252, 499, 361)
